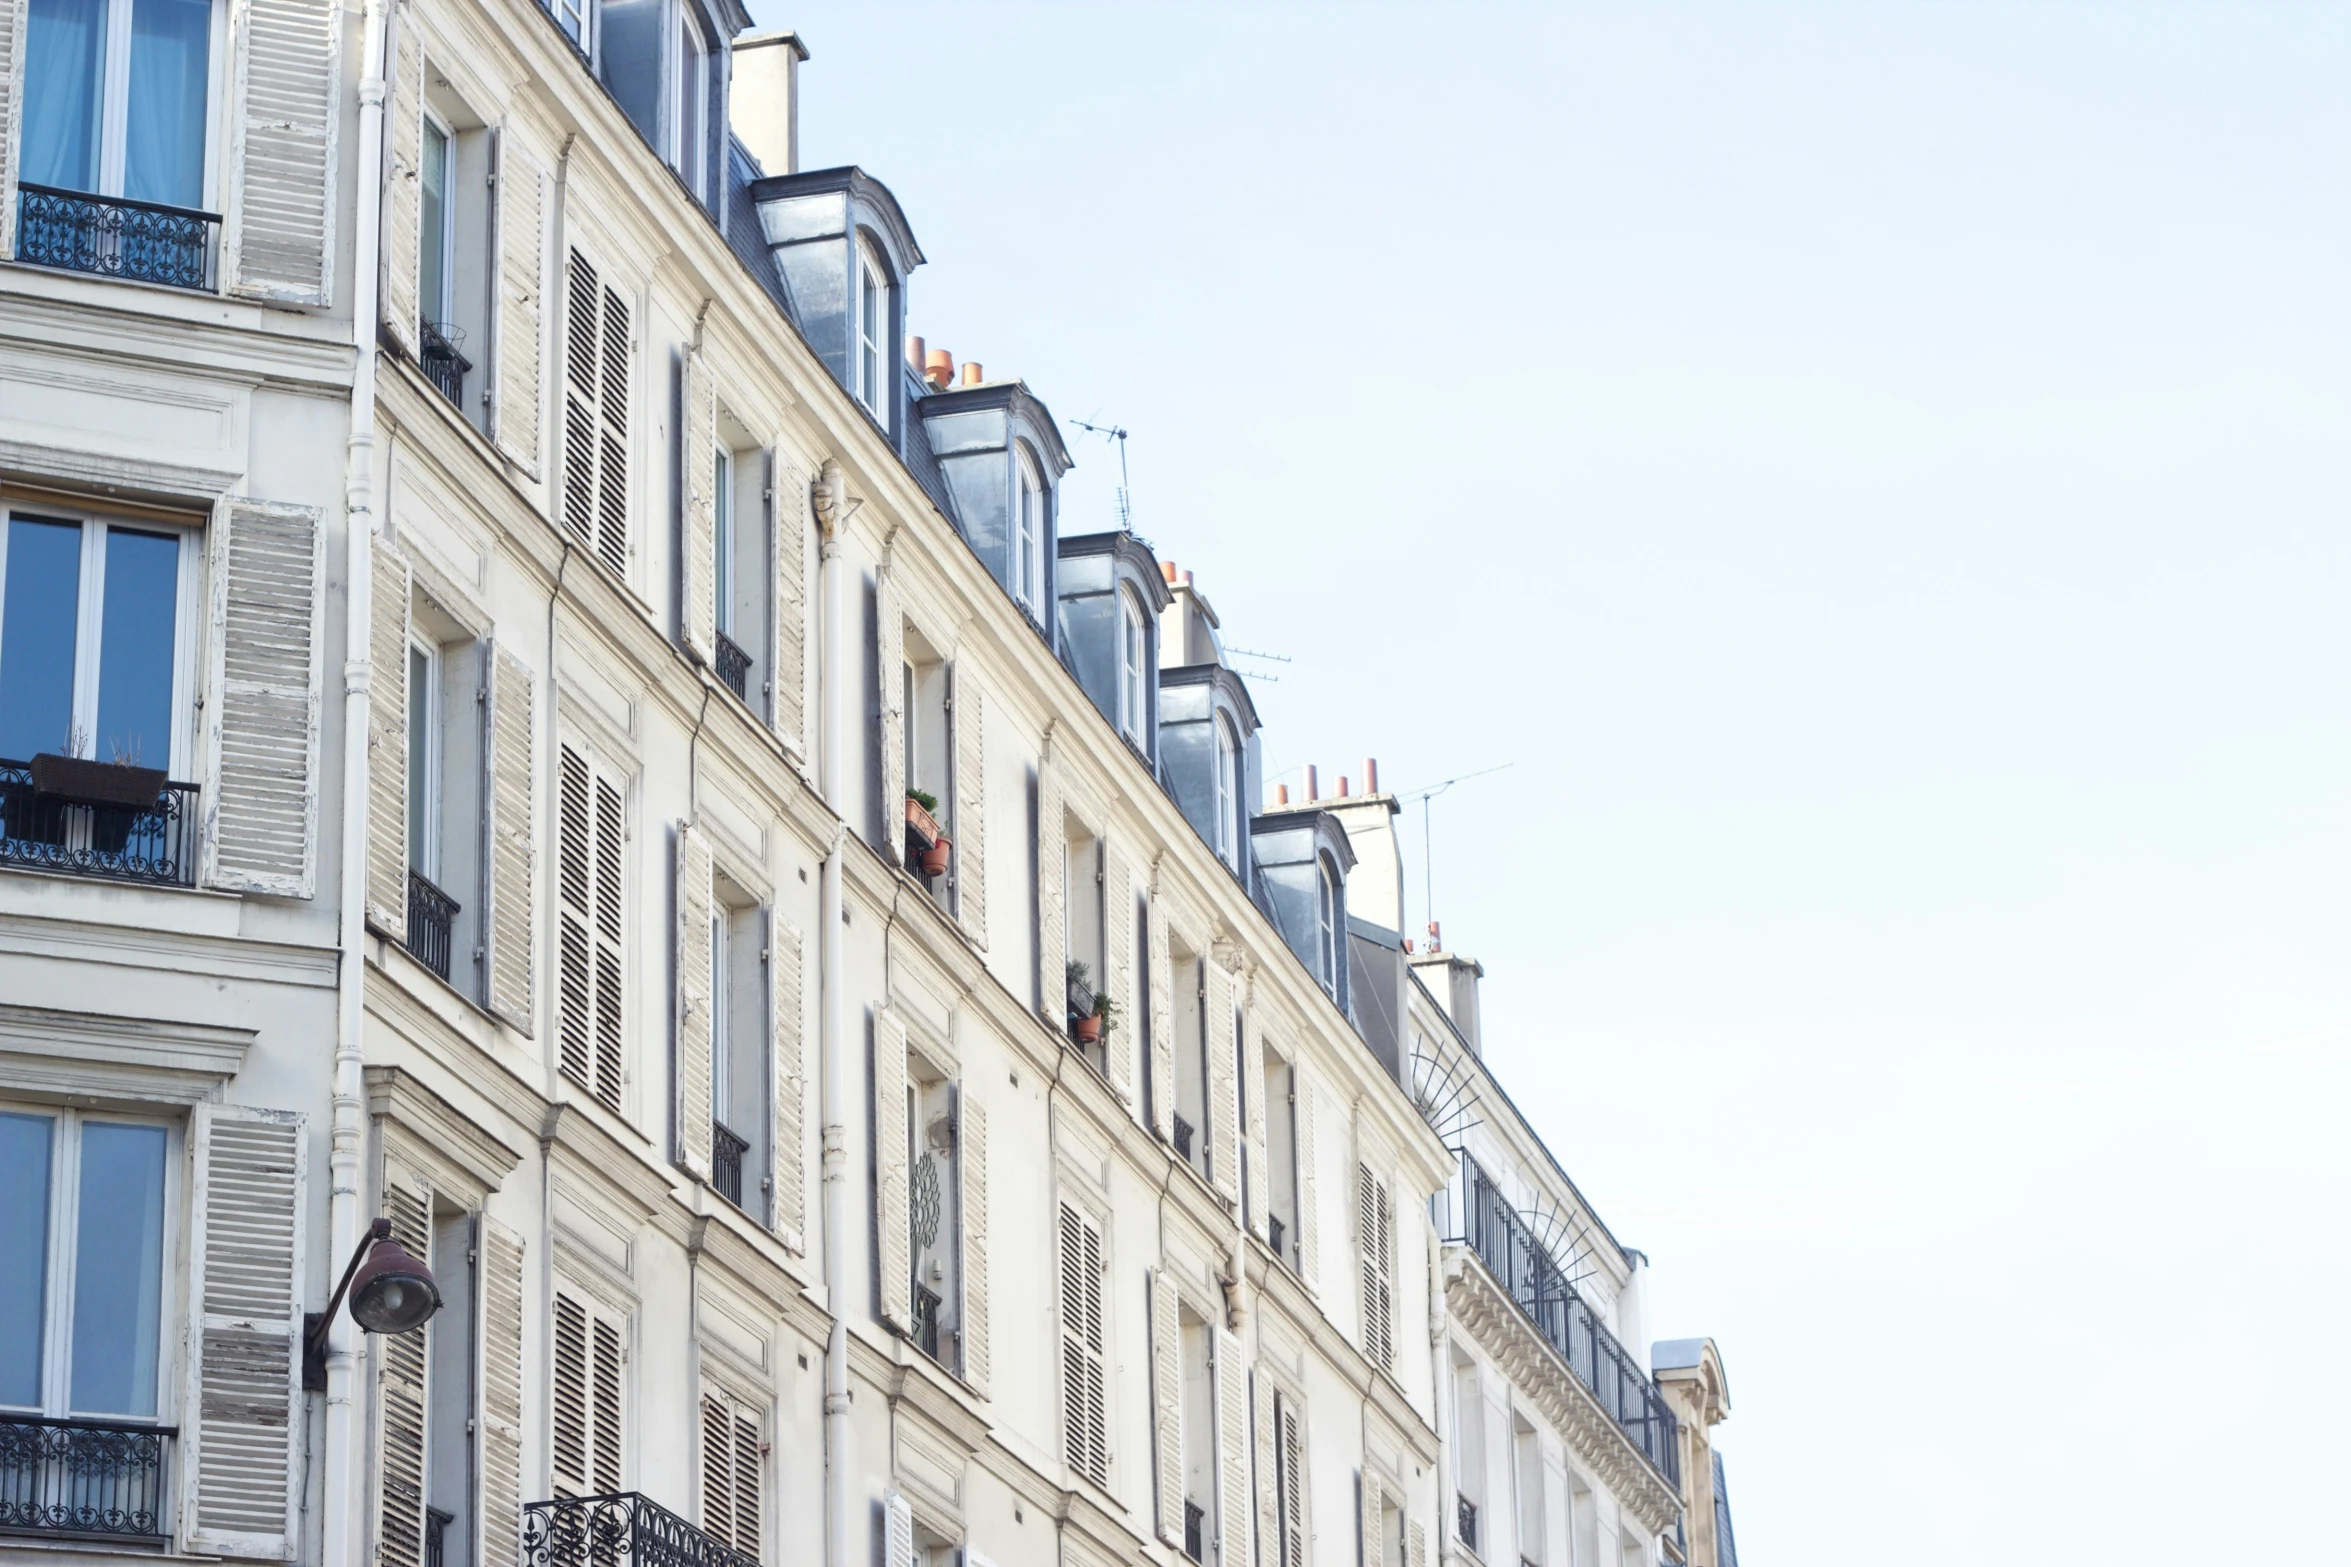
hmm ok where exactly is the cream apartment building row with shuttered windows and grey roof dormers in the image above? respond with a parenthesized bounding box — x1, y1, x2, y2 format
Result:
(0, 0, 1721, 1567)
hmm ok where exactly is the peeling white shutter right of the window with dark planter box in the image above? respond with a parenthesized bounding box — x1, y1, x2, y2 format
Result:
(205, 498, 327, 897)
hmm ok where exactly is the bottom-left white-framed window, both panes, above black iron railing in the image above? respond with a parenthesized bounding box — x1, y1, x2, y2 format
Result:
(0, 1109, 176, 1419)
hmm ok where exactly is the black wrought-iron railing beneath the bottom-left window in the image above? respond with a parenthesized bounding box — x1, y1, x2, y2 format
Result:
(0, 1414, 179, 1541)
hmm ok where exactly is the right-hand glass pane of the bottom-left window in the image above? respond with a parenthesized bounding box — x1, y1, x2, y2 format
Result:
(73, 1121, 165, 1414)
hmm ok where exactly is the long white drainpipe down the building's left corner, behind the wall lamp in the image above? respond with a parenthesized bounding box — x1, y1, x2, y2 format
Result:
(320, 0, 388, 1565)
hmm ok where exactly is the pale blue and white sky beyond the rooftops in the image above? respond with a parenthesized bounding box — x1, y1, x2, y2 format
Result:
(755, 0, 2351, 1567)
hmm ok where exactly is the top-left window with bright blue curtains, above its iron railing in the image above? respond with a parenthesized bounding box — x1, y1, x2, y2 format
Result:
(16, 0, 214, 207)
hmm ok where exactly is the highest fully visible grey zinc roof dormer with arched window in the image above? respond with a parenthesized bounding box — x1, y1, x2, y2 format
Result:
(750, 169, 922, 446)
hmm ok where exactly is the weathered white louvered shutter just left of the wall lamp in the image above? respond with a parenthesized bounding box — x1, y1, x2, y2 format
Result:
(179, 1104, 310, 1560)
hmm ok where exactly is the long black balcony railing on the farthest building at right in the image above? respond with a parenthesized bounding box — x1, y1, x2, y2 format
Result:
(1448, 1154, 1681, 1489)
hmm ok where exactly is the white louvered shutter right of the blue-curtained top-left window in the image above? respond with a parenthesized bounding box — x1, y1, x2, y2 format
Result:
(221, 0, 343, 305)
